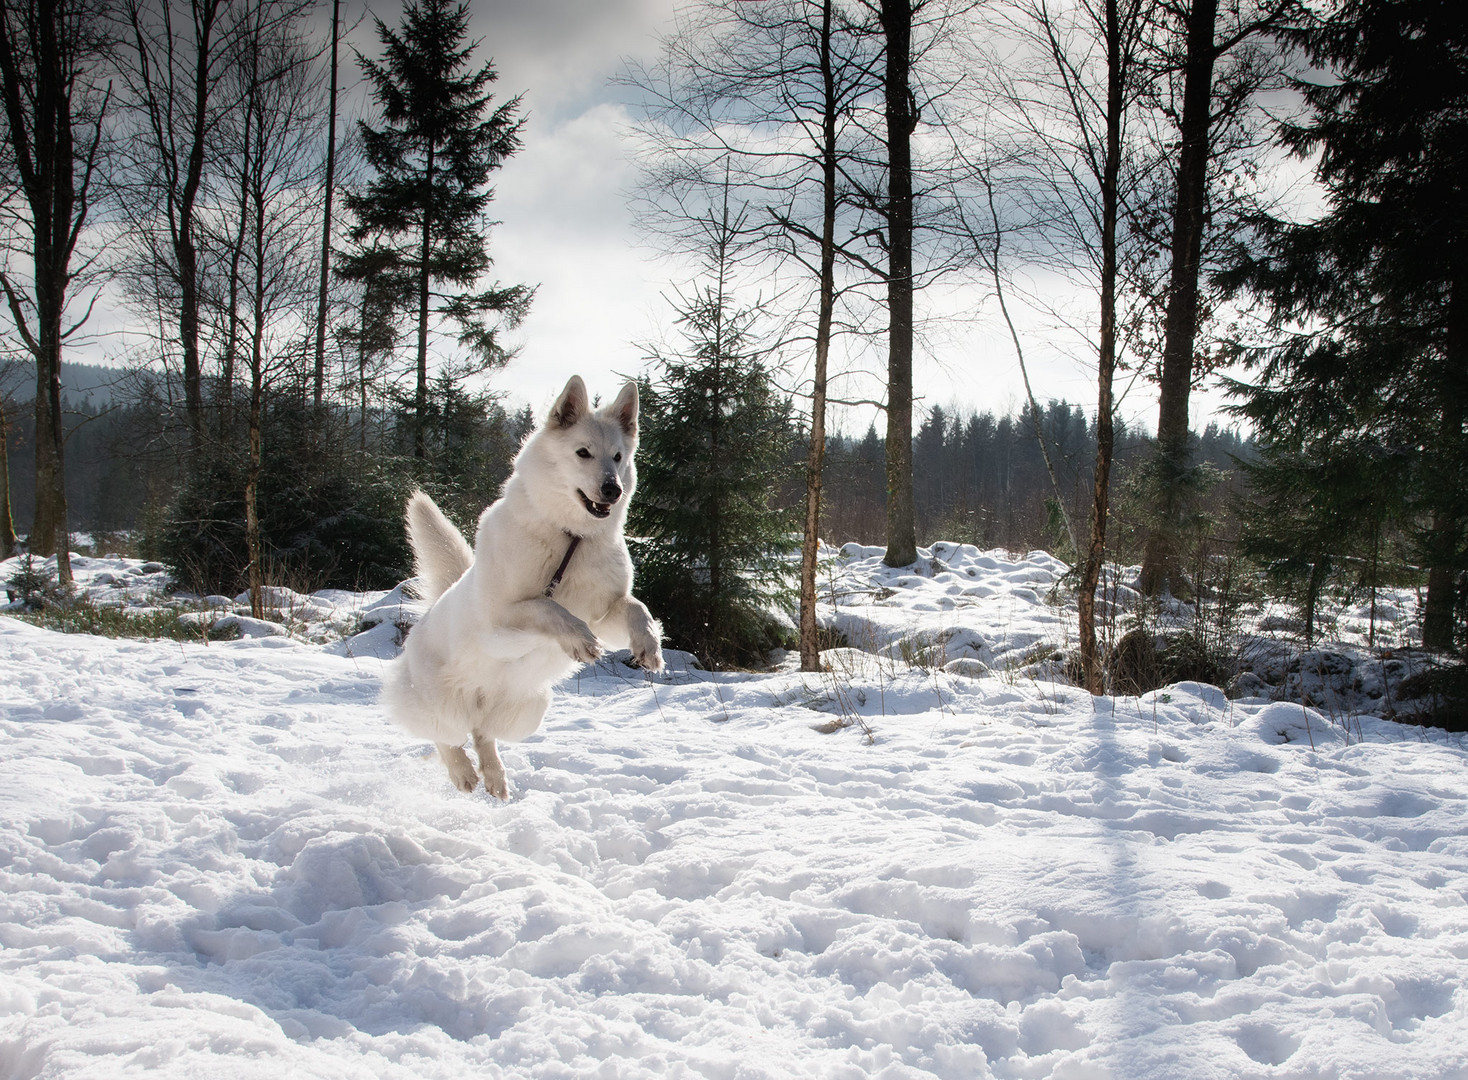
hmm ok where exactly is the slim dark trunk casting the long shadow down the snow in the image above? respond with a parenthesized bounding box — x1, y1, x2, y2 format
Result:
(1079, 0, 1124, 694)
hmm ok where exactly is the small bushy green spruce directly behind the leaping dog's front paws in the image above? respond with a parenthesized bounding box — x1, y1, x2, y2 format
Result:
(628, 276, 799, 665)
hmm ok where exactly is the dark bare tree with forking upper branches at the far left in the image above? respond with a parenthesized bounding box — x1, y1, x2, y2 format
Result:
(0, 0, 112, 584)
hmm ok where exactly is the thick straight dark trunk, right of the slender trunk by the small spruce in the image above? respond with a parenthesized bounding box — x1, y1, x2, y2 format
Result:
(881, 0, 918, 566)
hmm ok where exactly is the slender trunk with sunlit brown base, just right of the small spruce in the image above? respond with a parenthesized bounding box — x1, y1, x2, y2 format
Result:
(800, 0, 837, 671)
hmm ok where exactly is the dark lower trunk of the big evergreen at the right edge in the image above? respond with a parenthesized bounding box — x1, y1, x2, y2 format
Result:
(1422, 279, 1468, 652)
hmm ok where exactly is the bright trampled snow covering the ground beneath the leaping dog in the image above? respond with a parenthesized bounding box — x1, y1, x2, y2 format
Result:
(0, 546, 1468, 1080)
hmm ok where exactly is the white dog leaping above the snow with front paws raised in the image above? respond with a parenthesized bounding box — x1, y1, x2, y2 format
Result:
(383, 376, 662, 798)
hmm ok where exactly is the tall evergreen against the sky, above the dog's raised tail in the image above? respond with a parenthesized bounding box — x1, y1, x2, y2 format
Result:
(342, 0, 533, 458)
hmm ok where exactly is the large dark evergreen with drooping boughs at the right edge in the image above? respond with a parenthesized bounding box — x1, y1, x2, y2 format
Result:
(1229, 0, 1468, 649)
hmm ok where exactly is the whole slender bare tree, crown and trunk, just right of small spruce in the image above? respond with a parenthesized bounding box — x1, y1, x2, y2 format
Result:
(631, 0, 879, 671)
